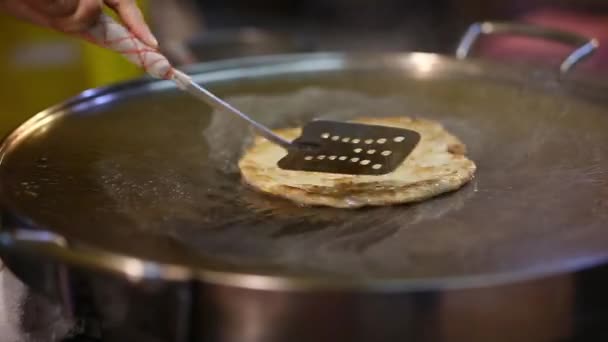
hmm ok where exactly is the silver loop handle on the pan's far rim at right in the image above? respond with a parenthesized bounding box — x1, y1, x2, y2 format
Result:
(456, 22, 599, 75)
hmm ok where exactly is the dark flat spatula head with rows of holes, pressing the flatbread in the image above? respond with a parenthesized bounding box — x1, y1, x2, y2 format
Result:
(278, 120, 420, 175)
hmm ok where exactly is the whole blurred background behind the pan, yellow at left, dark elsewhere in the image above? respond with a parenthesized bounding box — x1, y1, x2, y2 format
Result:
(0, 0, 608, 133)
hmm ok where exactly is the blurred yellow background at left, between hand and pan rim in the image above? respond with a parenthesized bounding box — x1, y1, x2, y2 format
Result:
(0, 1, 148, 136)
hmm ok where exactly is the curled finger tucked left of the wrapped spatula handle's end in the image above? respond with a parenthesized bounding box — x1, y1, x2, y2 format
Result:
(51, 0, 101, 34)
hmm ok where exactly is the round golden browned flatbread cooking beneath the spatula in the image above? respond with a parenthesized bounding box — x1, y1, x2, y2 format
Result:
(239, 117, 476, 208)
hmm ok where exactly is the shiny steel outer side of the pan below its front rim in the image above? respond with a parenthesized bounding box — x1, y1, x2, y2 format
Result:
(3, 248, 608, 342)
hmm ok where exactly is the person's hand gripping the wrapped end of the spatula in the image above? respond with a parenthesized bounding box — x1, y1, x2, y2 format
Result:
(0, 0, 158, 47)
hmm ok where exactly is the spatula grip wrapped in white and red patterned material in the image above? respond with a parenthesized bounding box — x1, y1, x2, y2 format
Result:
(82, 14, 190, 88)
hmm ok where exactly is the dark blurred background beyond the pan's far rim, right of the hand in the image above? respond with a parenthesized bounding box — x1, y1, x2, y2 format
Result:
(159, 0, 608, 61)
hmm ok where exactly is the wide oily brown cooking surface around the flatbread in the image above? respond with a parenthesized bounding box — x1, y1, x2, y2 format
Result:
(0, 55, 608, 286)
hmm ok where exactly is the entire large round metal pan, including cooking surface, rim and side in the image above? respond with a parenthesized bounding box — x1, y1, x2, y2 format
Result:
(0, 22, 608, 341)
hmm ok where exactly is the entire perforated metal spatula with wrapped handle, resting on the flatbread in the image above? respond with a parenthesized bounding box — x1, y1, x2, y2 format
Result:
(83, 14, 420, 175)
